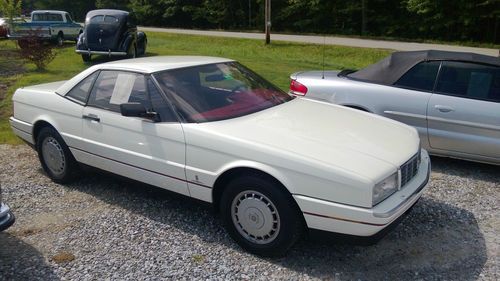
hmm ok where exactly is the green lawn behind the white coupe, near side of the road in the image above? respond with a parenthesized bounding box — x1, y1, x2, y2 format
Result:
(0, 32, 389, 144)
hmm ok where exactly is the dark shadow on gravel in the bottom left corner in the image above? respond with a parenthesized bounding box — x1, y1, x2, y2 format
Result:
(0, 232, 60, 281)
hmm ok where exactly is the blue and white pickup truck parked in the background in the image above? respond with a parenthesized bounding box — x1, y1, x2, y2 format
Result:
(7, 10, 82, 47)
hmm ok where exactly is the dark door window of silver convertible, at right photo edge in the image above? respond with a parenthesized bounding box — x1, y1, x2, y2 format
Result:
(436, 62, 500, 102)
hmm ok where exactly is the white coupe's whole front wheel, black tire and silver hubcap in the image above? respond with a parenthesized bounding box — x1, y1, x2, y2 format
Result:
(220, 175, 304, 257)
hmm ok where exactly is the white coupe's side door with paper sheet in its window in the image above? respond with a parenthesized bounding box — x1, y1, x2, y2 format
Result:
(82, 70, 189, 195)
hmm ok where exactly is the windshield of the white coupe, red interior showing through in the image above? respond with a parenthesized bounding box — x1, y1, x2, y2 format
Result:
(154, 62, 292, 123)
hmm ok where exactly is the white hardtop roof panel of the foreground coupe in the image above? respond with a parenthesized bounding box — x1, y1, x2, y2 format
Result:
(98, 56, 234, 73)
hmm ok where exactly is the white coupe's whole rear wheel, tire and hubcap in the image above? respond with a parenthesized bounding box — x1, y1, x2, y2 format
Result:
(36, 127, 78, 183)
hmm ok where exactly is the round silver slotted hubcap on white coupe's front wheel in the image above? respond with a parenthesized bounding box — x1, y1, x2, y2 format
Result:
(231, 190, 280, 244)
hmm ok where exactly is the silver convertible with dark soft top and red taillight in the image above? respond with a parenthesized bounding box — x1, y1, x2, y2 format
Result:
(290, 51, 500, 165)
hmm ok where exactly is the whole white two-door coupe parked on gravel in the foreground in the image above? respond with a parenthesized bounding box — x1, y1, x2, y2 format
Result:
(10, 57, 430, 256)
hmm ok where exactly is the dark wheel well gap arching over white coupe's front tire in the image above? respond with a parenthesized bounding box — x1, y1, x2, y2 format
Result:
(212, 167, 292, 211)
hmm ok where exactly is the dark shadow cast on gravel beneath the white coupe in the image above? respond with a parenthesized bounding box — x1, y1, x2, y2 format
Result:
(61, 169, 487, 280)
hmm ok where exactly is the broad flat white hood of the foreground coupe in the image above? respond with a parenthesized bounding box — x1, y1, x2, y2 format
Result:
(189, 98, 419, 182)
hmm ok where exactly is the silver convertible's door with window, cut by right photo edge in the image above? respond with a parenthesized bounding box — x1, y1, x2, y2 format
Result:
(428, 61, 500, 160)
